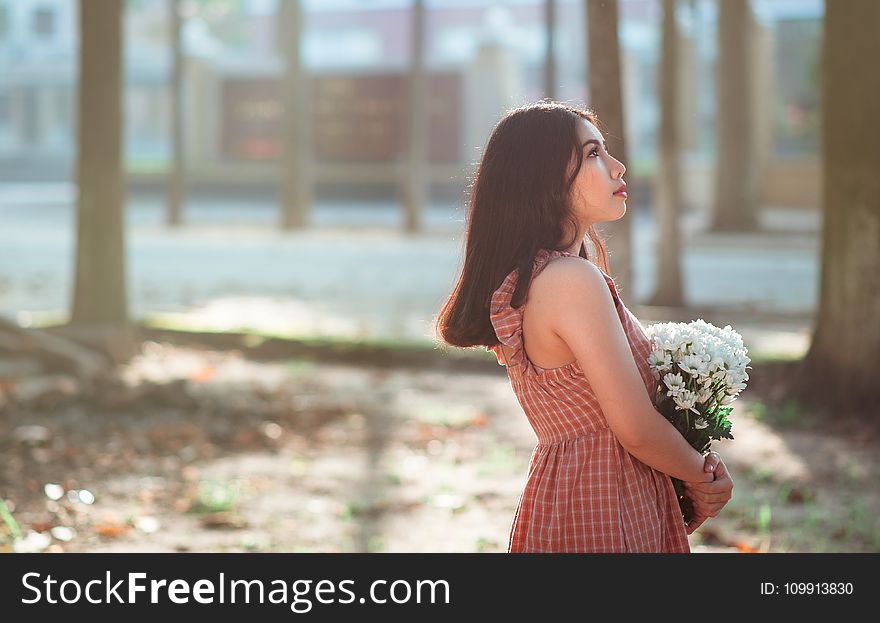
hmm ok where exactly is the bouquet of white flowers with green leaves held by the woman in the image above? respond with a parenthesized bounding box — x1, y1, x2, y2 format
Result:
(645, 318, 751, 522)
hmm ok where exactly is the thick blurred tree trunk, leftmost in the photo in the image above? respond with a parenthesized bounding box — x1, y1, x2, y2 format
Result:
(70, 0, 133, 360)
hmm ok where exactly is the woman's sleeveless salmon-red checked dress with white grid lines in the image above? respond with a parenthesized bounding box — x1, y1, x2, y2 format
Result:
(489, 249, 690, 553)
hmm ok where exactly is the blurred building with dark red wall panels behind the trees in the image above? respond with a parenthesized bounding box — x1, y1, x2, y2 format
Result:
(0, 0, 822, 205)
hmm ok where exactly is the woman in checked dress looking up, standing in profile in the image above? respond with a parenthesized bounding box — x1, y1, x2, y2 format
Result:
(437, 101, 733, 552)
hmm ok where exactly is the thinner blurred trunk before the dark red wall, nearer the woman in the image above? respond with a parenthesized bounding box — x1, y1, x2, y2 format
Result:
(402, 0, 431, 233)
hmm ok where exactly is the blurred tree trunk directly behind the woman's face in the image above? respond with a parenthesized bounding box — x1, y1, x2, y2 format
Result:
(585, 0, 633, 292)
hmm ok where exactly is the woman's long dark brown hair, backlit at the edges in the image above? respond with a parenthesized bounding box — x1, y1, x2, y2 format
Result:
(436, 100, 609, 348)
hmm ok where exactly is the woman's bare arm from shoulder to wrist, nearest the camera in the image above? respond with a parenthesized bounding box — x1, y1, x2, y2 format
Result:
(530, 258, 713, 482)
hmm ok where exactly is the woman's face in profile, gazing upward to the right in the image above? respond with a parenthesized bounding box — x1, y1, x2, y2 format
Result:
(571, 119, 626, 229)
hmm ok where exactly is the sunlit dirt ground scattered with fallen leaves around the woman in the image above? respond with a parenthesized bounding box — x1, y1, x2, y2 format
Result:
(0, 342, 880, 552)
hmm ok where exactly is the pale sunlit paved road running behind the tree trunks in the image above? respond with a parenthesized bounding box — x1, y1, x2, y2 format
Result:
(0, 187, 818, 350)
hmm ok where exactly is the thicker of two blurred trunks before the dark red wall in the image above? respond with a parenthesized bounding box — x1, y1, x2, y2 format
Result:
(278, 0, 312, 229)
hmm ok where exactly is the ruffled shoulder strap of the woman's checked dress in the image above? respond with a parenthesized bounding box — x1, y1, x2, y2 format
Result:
(489, 249, 620, 368)
